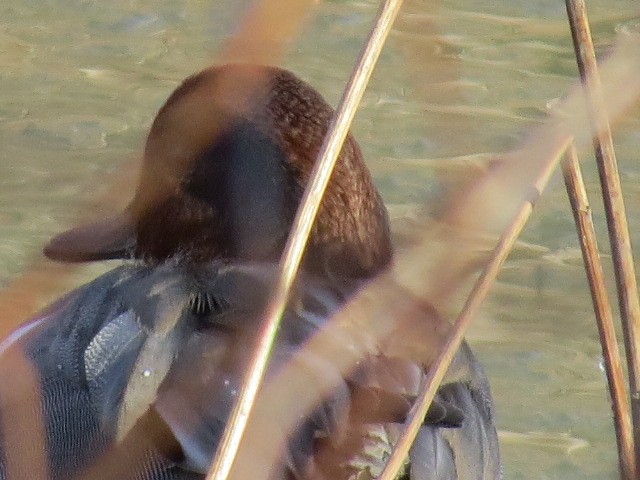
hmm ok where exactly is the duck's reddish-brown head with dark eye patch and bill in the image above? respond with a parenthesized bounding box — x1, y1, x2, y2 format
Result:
(44, 65, 392, 278)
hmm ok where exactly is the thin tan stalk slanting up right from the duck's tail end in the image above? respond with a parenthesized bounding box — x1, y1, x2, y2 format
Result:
(379, 138, 570, 480)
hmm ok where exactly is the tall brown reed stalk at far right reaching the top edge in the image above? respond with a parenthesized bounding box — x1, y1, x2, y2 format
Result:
(566, 0, 640, 470)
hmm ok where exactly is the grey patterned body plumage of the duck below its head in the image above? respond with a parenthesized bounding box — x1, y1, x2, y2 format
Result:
(0, 264, 500, 480)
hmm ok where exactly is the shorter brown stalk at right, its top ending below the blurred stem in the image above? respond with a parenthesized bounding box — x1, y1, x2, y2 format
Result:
(562, 143, 638, 480)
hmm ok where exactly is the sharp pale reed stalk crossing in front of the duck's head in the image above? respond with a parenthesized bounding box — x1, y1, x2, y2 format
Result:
(206, 0, 402, 480)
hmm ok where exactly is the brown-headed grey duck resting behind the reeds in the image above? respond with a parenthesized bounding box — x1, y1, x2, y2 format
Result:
(0, 64, 502, 480)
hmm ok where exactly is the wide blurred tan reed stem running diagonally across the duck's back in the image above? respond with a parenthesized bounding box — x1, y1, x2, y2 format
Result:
(225, 34, 640, 479)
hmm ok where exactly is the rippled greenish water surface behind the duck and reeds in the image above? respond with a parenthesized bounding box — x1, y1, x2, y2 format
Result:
(0, 0, 640, 479)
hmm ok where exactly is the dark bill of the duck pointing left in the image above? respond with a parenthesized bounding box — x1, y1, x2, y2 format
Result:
(43, 210, 136, 263)
